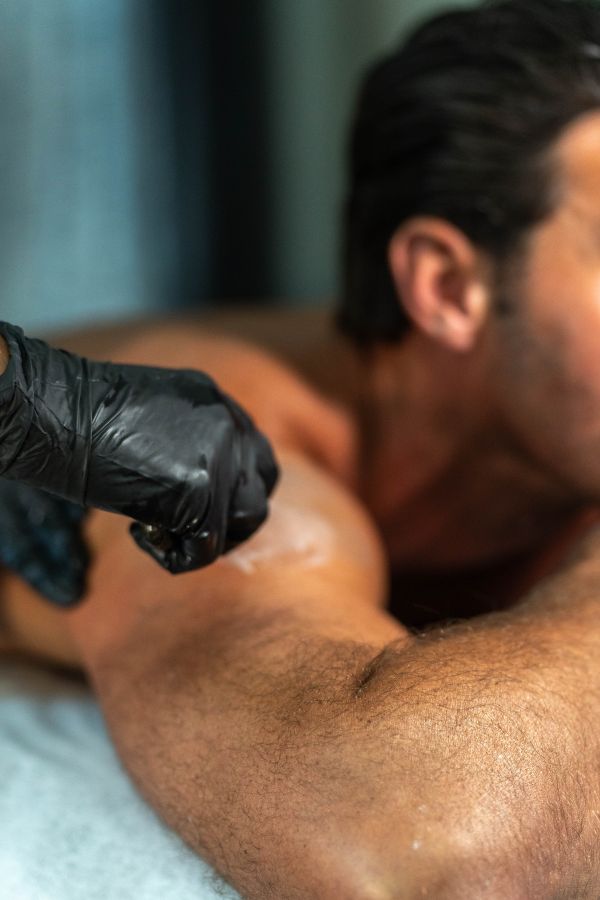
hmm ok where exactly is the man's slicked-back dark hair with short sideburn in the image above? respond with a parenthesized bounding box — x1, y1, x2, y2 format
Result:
(337, 0, 600, 342)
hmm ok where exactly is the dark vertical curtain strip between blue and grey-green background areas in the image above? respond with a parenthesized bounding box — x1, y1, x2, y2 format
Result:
(160, 0, 269, 307)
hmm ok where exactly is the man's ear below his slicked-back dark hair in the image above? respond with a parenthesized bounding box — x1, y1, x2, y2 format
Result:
(388, 216, 490, 352)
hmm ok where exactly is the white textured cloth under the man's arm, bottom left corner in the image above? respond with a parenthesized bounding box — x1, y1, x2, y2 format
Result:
(0, 662, 240, 900)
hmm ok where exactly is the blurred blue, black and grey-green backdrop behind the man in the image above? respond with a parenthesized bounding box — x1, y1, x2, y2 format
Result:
(0, 0, 478, 334)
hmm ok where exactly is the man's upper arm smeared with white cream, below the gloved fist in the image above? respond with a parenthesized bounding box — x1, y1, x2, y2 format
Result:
(2, 449, 404, 664)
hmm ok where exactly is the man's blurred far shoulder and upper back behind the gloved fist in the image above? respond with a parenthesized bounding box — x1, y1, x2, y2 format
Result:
(54, 309, 357, 486)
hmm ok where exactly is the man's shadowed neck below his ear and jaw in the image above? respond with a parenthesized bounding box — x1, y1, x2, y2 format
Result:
(358, 335, 581, 569)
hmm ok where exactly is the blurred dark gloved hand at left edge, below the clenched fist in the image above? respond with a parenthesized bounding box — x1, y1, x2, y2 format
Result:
(0, 478, 89, 607)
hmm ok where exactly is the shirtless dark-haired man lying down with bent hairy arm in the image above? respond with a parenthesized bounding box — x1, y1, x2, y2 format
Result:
(2, 0, 600, 900)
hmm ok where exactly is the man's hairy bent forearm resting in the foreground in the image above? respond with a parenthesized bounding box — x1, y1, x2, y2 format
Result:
(75, 536, 600, 900)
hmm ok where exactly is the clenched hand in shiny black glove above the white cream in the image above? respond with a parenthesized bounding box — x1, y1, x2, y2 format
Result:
(0, 323, 277, 572)
